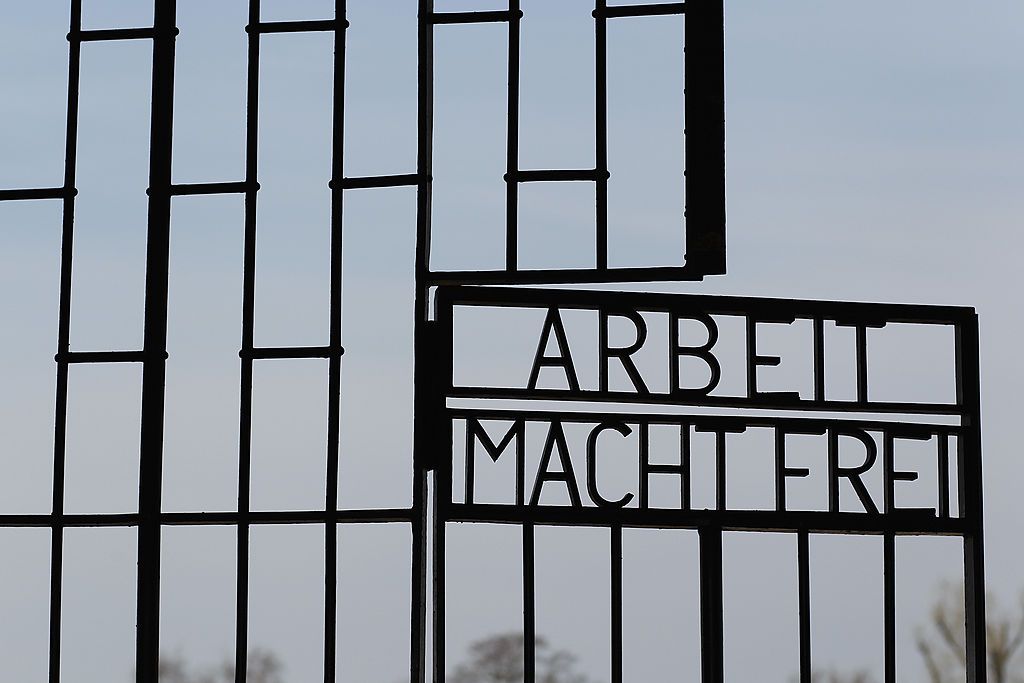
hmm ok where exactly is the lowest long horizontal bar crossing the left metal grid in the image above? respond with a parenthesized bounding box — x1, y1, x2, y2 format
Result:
(0, 508, 414, 528)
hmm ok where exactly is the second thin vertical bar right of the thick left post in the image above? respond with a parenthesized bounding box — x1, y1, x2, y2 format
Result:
(324, 0, 347, 683)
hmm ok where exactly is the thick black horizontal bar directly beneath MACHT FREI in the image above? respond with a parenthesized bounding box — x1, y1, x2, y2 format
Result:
(440, 503, 973, 537)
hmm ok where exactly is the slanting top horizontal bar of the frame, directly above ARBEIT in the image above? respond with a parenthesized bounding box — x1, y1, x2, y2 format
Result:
(437, 287, 977, 326)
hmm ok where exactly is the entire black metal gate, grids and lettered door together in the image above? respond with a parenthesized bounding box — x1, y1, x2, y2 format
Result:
(0, 0, 985, 683)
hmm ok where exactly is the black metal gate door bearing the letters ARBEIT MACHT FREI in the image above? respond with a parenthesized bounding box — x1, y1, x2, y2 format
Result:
(433, 287, 985, 683)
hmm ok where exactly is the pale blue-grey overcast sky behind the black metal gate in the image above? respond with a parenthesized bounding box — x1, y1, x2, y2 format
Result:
(0, 0, 1024, 683)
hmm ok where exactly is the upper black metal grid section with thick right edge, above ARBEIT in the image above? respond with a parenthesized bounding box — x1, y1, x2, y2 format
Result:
(428, 0, 725, 285)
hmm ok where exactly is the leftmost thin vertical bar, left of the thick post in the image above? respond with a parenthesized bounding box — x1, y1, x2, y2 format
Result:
(49, 5, 82, 683)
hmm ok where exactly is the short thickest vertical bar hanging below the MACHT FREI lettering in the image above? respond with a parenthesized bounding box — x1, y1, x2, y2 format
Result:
(697, 526, 725, 683)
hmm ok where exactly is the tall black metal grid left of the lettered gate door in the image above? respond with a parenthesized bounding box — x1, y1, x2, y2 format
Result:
(0, 0, 421, 683)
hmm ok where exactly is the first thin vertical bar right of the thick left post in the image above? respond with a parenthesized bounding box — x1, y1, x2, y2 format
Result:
(234, 0, 260, 683)
